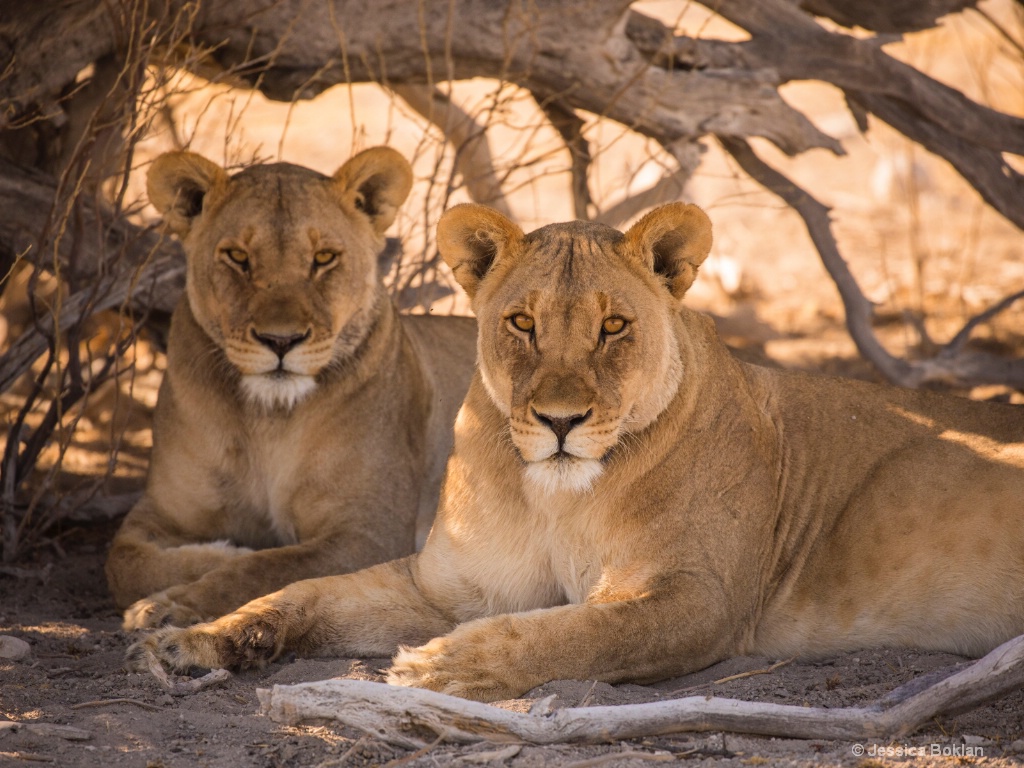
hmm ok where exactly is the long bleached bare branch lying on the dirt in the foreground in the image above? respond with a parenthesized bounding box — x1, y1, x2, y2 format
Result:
(257, 636, 1024, 748)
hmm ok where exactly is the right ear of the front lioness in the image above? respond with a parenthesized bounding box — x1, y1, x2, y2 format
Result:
(626, 203, 711, 299)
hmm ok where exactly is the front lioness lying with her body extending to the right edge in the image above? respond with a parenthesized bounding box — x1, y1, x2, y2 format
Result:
(129, 204, 1024, 700)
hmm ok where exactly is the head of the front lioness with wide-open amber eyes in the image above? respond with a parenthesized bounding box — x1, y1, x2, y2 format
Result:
(437, 203, 711, 492)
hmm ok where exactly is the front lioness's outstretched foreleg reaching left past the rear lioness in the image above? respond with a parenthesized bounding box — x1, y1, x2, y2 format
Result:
(128, 555, 455, 671)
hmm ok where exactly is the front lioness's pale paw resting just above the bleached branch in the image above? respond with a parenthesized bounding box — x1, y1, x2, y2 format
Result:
(387, 636, 534, 701)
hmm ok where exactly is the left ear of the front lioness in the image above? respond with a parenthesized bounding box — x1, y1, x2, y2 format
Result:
(437, 203, 523, 298)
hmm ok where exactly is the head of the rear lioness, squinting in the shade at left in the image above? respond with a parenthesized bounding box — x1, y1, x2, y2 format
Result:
(147, 147, 413, 408)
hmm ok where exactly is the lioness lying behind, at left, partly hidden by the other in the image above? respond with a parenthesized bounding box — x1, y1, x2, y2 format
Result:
(106, 147, 476, 629)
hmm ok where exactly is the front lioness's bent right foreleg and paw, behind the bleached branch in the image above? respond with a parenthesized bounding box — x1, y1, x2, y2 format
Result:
(388, 597, 729, 701)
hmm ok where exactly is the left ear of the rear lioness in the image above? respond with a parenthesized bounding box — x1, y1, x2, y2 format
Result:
(145, 152, 227, 238)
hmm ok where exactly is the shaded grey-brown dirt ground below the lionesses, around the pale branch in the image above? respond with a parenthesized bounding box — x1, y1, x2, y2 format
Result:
(0, 526, 1024, 768)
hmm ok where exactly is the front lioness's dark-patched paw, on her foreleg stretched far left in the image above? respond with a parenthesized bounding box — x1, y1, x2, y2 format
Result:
(125, 613, 283, 672)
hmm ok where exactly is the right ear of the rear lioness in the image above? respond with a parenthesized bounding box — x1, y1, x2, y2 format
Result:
(334, 146, 413, 234)
